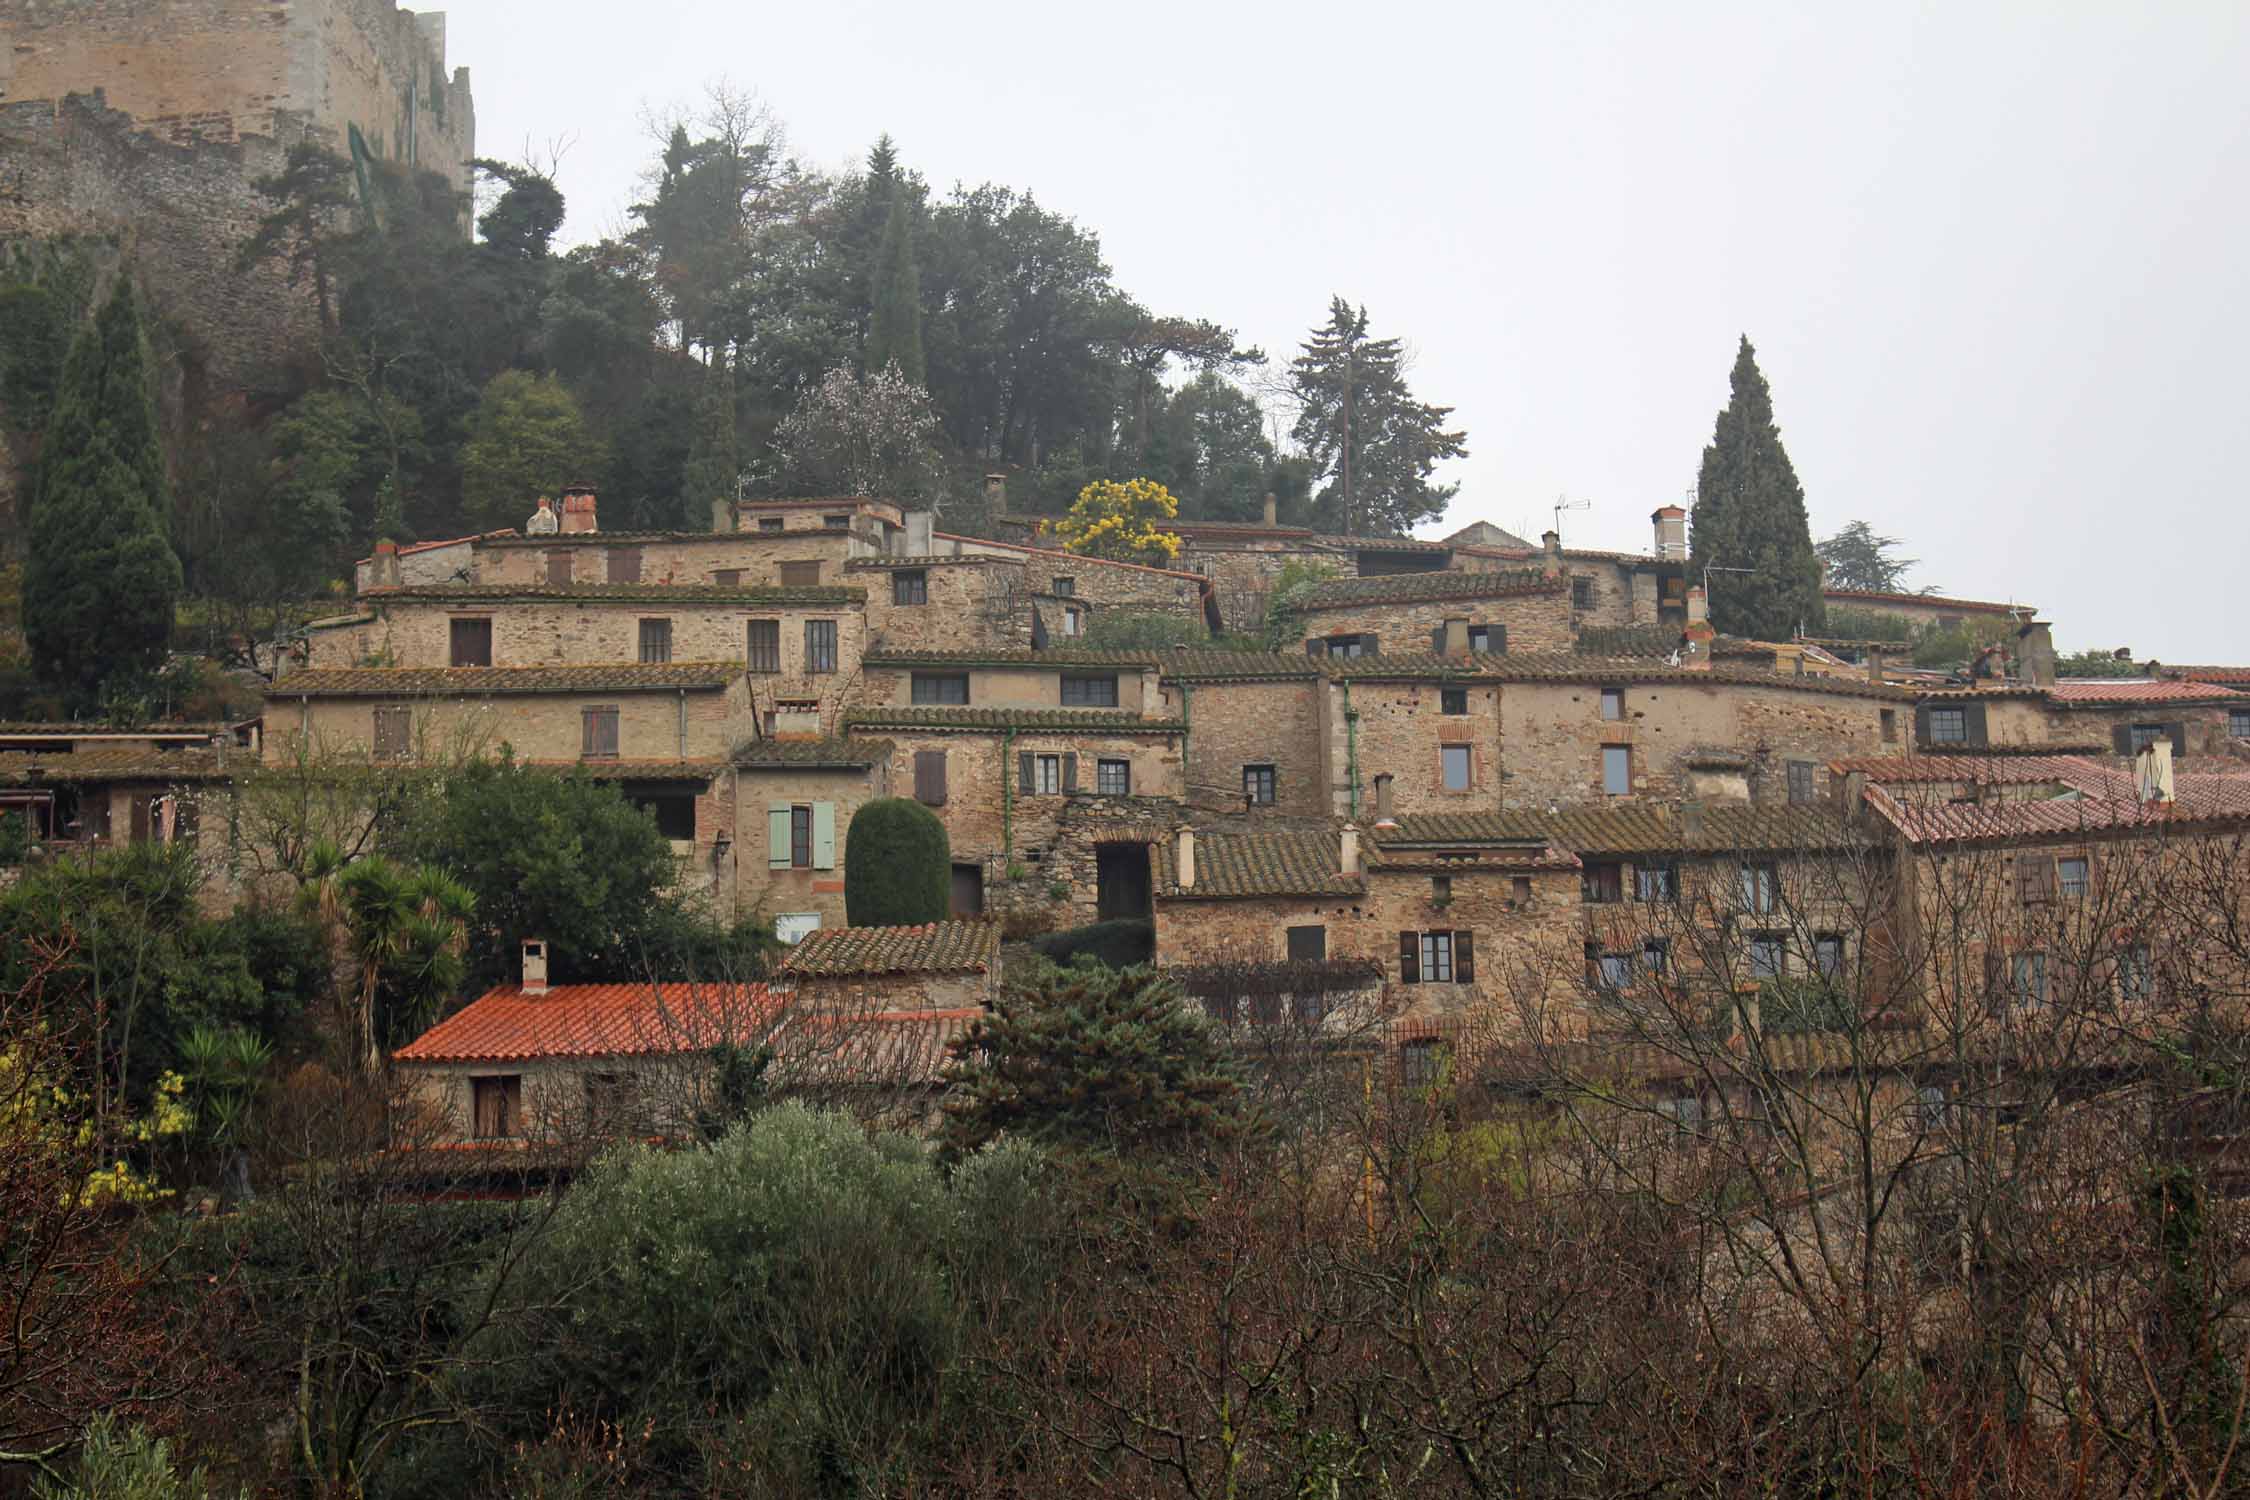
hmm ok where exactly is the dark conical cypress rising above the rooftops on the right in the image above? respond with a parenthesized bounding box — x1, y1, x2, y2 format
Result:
(1690, 335, 1827, 641)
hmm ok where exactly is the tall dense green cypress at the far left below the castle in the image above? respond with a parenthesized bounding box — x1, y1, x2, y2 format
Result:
(23, 277, 180, 702)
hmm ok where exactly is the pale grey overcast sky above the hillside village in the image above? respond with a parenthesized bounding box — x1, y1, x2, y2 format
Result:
(448, 0, 2250, 663)
